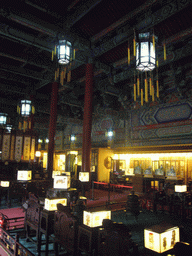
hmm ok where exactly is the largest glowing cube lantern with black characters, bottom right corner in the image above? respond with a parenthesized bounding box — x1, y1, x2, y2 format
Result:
(144, 225, 180, 253)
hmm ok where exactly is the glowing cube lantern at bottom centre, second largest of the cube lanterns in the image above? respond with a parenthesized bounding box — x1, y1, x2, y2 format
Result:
(83, 211, 111, 228)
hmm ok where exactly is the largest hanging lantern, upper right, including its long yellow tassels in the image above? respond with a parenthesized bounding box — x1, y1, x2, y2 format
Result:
(128, 32, 159, 106)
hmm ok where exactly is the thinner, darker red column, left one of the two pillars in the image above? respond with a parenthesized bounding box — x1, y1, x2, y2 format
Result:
(47, 82, 58, 179)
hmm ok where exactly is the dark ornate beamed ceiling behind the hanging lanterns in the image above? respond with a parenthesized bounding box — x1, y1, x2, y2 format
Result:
(0, 0, 192, 135)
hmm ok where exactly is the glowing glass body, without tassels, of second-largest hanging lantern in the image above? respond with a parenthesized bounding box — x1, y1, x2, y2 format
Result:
(57, 40, 72, 65)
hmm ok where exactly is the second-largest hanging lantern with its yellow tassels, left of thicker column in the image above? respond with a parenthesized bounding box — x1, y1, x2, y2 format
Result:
(52, 40, 75, 85)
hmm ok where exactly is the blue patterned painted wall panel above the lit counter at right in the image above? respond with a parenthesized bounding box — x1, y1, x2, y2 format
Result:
(131, 101, 192, 145)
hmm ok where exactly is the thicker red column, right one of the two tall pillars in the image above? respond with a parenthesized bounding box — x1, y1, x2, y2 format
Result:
(82, 63, 93, 177)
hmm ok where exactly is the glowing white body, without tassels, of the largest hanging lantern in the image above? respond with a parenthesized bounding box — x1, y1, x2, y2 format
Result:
(136, 32, 156, 72)
